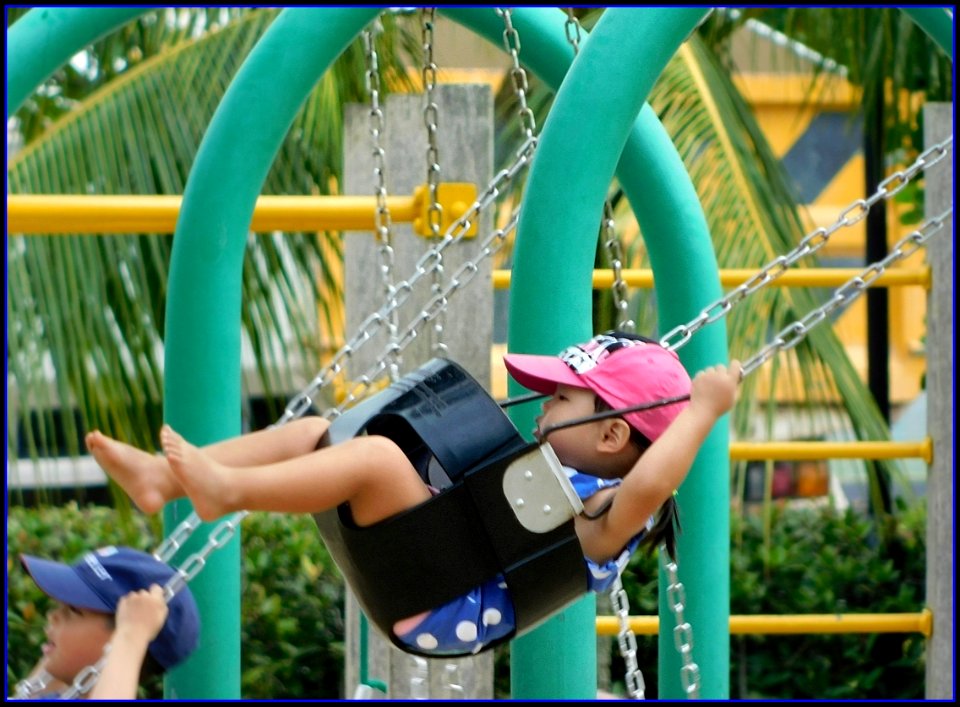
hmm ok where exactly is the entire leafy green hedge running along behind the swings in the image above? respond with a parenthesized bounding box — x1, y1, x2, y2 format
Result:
(7, 505, 925, 699)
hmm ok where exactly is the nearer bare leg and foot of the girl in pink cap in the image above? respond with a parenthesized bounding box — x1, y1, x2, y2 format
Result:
(160, 425, 430, 525)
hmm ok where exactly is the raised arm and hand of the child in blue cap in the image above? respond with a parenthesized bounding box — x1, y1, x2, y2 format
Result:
(89, 584, 167, 700)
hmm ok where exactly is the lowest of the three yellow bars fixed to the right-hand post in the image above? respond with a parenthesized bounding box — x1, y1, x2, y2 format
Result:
(597, 609, 933, 638)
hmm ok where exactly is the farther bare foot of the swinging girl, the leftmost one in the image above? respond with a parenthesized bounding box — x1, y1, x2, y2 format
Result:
(86, 430, 183, 513)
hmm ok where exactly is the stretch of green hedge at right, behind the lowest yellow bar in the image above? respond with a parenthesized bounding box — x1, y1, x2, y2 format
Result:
(611, 508, 926, 700)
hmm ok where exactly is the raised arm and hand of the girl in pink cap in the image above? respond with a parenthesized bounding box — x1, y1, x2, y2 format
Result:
(581, 361, 741, 562)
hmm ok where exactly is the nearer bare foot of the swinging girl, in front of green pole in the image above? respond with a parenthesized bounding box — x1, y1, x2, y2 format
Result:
(160, 425, 236, 520)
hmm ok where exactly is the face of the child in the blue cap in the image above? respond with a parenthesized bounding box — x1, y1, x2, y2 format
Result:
(43, 603, 113, 683)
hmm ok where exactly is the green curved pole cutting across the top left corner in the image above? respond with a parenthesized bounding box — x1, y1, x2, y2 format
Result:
(7, 7, 152, 118)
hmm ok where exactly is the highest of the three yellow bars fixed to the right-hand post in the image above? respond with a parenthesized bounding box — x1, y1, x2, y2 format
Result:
(493, 266, 930, 290)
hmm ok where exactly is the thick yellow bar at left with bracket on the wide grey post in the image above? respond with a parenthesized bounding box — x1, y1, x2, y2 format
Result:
(7, 182, 477, 236)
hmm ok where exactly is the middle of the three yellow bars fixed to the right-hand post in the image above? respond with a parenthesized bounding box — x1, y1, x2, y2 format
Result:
(730, 437, 933, 464)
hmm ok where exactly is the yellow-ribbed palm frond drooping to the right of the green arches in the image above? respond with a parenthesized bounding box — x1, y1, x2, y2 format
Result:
(651, 38, 908, 516)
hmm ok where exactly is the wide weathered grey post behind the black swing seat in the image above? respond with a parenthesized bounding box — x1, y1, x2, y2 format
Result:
(344, 85, 493, 699)
